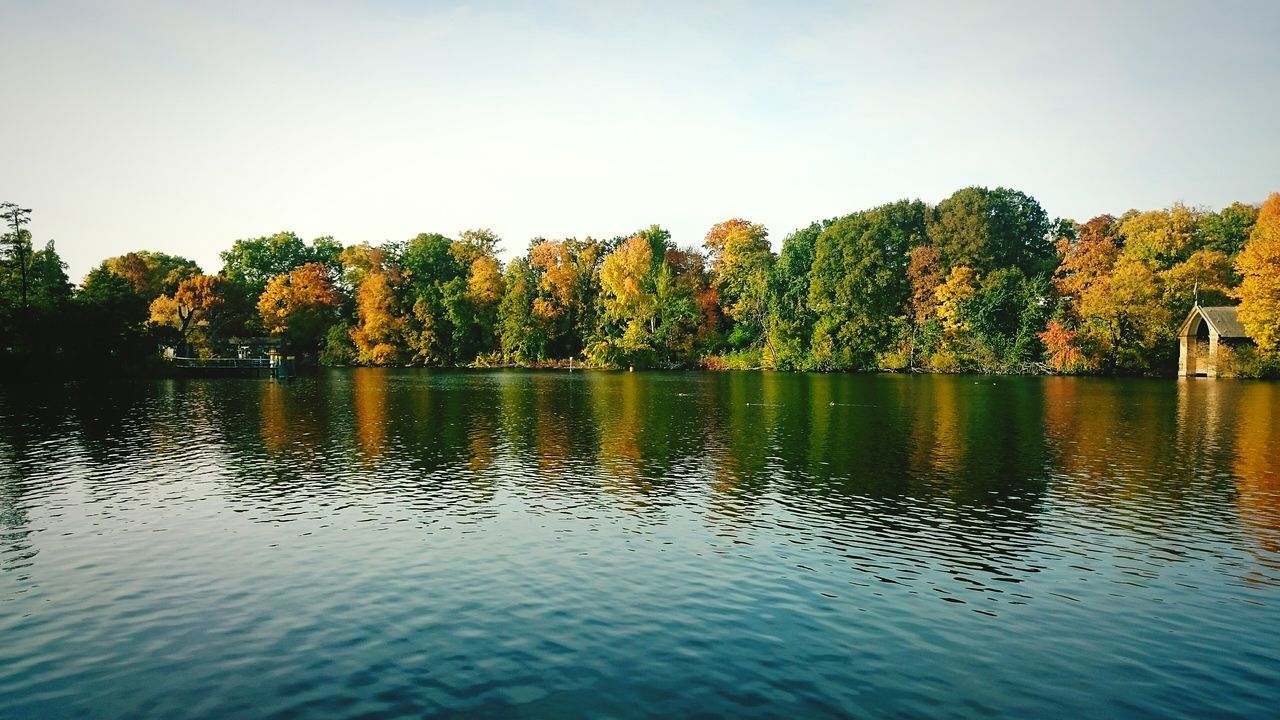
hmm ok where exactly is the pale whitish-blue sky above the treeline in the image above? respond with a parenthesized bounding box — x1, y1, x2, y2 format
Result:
(0, 0, 1280, 281)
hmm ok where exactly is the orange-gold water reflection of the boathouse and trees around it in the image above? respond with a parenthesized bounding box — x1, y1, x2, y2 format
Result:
(1044, 378, 1280, 580)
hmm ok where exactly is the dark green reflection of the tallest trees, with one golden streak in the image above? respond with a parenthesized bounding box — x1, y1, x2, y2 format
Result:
(786, 375, 1046, 592)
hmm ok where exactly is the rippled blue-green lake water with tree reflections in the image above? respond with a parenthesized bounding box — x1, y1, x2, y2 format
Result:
(0, 369, 1280, 719)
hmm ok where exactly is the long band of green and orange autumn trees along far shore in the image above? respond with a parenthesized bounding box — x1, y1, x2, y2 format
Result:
(0, 187, 1280, 377)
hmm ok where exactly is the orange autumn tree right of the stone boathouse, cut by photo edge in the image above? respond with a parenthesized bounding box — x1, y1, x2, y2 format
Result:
(1235, 192, 1280, 354)
